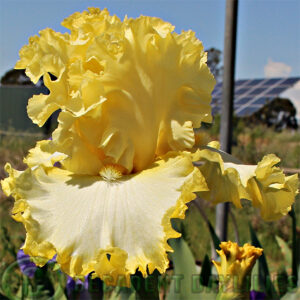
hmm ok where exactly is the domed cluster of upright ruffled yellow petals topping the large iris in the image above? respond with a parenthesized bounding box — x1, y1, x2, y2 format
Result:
(16, 8, 215, 175)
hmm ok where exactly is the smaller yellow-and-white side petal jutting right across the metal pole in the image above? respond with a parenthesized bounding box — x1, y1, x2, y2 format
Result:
(199, 150, 298, 221)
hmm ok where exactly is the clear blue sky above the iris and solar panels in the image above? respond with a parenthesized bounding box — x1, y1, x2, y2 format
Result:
(0, 0, 300, 79)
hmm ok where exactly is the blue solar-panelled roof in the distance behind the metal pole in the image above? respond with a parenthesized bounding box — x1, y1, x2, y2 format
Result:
(212, 77, 300, 117)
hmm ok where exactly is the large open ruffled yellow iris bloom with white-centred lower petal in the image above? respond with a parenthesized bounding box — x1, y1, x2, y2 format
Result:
(2, 8, 297, 284)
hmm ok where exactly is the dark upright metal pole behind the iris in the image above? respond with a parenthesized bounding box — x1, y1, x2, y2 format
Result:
(216, 0, 238, 241)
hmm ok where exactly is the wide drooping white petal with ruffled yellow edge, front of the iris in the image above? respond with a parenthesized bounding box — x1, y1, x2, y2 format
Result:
(2, 153, 207, 284)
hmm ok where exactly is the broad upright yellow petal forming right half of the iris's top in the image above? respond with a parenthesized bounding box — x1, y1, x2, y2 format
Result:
(83, 17, 214, 171)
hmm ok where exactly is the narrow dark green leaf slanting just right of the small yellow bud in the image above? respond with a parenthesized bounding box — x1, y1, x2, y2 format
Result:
(249, 223, 279, 299)
